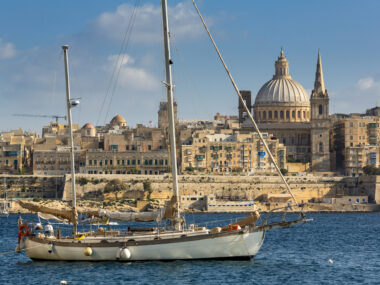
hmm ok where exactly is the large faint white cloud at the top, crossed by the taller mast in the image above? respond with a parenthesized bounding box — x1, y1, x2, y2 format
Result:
(95, 3, 206, 43)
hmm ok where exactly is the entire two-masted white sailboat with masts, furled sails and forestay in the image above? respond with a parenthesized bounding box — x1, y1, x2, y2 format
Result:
(18, 0, 307, 261)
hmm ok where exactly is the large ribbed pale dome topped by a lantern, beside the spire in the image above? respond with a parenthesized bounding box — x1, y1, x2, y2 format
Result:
(255, 50, 310, 107)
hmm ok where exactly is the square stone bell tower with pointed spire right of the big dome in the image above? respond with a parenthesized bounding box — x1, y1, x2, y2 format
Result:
(310, 51, 331, 171)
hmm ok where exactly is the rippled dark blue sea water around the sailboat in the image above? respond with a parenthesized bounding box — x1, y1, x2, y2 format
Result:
(0, 213, 380, 285)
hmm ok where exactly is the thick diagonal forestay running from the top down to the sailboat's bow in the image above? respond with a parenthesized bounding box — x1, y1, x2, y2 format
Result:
(192, 0, 300, 211)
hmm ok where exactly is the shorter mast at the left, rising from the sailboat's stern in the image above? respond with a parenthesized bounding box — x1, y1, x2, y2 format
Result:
(62, 45, 77, 233)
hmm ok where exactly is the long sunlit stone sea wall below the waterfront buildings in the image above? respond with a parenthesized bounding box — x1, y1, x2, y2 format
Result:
(63, 171, 380, 203)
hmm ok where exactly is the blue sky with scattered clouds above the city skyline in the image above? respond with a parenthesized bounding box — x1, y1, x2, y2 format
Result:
(0, 0, 380, 132)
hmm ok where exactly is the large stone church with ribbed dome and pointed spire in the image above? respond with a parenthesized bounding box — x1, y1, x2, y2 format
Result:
(243, 50, 330, 171)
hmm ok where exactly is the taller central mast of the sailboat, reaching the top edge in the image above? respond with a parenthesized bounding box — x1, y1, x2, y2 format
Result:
(161, 0, 181, 226)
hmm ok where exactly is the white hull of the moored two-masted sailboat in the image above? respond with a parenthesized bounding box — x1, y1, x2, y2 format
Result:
(24, 231, 265, 261)
